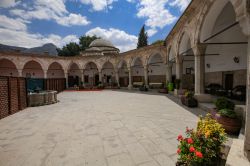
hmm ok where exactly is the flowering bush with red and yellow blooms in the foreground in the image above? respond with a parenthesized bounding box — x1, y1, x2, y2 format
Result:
(176, 114, 227, 166)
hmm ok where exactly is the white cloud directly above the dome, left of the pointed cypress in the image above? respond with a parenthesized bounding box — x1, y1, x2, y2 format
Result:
(86, 27, 137, 52)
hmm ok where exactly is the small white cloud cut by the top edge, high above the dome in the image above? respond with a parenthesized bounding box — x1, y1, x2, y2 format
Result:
(80, 0, 117, 11)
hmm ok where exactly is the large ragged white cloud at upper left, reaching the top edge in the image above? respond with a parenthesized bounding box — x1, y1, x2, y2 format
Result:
(10, 0, 90, 26)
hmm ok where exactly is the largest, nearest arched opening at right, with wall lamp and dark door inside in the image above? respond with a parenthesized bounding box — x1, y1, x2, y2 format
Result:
(200, 0, 248, 100)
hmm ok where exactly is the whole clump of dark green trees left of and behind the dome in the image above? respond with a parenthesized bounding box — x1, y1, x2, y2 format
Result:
(57, 36, 99, 56)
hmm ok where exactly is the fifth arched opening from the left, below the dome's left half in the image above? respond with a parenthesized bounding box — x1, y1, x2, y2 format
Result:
(84, 62, 100, 87)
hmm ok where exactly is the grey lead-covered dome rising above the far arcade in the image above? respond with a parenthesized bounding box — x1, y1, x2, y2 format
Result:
(86, 39, 120, 55)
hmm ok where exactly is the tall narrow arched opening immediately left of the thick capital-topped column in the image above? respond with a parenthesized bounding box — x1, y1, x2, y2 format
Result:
(176, 33, 195, 90)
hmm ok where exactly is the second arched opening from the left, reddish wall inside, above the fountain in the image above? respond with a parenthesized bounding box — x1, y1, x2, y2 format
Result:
(22, 60, 46, 78)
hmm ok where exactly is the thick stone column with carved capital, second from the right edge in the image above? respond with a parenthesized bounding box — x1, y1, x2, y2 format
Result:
(193, 45, 206, 95)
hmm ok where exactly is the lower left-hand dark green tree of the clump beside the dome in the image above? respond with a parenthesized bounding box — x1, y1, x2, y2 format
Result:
(57, 42, 80, 56)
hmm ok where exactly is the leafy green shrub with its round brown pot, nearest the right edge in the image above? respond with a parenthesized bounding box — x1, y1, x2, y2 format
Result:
(213, 97, 241, 134)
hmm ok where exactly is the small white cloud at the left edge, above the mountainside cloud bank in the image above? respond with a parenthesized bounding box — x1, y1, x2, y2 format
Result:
(0, 15, 27, 31)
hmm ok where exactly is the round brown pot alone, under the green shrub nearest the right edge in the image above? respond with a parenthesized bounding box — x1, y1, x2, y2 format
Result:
(213, 113, 241, 134)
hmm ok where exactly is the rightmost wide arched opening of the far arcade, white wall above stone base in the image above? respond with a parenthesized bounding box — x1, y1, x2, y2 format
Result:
(148, 54, 166, 88)
